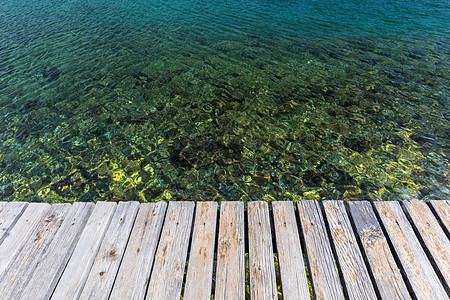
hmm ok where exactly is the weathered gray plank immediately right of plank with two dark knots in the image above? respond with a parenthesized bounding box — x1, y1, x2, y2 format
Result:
(110, 202, 167, 300)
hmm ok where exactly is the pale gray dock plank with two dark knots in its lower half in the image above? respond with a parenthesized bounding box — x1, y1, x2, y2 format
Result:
(80, 202, 139, 300)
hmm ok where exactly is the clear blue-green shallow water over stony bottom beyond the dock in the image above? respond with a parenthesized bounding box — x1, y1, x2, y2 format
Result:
(0, 0, 450, 202)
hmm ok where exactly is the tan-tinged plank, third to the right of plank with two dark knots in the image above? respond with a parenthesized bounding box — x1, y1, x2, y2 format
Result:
(183, 202, 217, 300)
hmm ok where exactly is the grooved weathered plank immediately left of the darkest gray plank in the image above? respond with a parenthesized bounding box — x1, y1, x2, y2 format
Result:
(323, 201, 377, 300)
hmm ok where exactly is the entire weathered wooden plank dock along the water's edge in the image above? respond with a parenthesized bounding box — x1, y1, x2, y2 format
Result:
(0, 200, 450, 300)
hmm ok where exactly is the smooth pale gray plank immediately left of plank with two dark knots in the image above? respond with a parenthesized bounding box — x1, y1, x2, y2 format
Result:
(52, 202, 116, 300)
